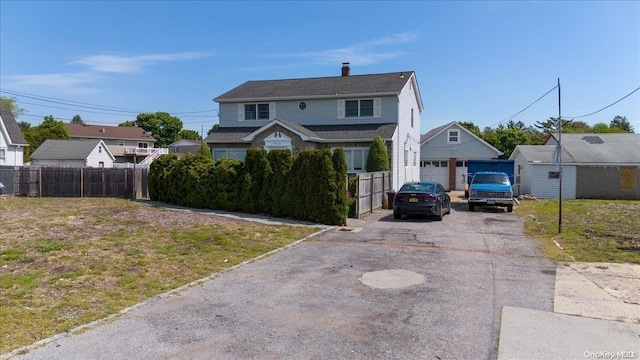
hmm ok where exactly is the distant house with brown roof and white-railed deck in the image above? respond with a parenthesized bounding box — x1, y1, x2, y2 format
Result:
(66, 124, 160, 163)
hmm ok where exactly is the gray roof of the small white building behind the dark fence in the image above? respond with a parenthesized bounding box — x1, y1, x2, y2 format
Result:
(31, 139, 115, 160)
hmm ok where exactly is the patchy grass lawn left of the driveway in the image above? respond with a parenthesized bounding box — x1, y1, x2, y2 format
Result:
(0, 198, 320, 353)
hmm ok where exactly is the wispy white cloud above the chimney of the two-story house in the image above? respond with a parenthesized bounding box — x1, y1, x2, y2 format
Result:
(266, 32, 419, 65)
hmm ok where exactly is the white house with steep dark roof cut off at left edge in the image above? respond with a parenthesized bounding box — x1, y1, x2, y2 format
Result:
(0, 101, 29, 166)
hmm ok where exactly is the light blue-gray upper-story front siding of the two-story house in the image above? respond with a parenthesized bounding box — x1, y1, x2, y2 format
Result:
(219, 96, 398, 127)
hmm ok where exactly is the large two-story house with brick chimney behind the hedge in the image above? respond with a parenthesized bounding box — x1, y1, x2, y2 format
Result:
(205, 63, 423, 190)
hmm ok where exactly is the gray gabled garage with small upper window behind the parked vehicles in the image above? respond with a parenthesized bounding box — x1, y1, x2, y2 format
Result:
(420, 121, 502, 190)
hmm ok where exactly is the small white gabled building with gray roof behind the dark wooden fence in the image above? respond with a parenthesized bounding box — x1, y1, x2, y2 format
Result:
(31, 139, 115, 168)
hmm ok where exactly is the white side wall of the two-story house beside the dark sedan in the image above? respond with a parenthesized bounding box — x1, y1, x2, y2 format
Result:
(393, 76, 420, 190)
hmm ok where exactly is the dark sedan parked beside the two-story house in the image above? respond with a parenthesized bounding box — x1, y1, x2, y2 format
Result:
(393, 181, 451, 221)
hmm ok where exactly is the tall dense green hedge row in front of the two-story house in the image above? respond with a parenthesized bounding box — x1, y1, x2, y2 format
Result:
(149, 149, 347, 225)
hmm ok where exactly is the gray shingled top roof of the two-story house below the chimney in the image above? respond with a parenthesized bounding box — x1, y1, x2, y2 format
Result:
(213, 71, 422, 105)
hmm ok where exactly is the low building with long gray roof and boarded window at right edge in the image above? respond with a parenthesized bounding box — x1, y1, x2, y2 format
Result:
(509, 133, 640, 200)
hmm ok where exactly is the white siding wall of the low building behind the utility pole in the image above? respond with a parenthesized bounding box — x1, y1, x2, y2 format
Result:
(530, 163, 576, 199)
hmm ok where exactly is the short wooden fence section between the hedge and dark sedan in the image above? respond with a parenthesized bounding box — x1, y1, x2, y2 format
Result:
(356, 171, 391, 219)
